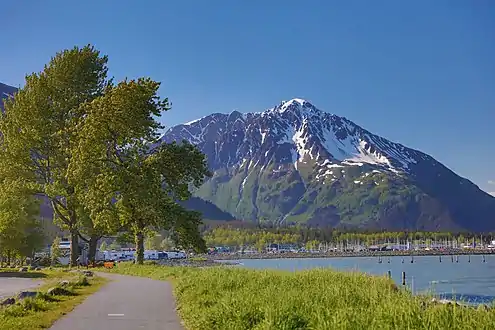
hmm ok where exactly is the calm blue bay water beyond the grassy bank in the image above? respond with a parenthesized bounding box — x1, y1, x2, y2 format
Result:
(230, 255, 495, 303)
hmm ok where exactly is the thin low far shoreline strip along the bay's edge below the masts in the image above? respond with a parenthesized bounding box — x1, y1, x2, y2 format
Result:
(204, 250, 495, 260)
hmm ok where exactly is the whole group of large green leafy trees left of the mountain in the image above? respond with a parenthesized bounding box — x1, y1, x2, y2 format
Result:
(0, 45, 210, 266)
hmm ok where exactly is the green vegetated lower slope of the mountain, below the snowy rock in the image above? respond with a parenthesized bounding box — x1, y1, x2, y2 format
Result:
(195, 159, 462, 231)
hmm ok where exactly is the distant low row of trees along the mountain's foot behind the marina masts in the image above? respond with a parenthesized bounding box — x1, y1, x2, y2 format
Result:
(204, 225, 493, 250)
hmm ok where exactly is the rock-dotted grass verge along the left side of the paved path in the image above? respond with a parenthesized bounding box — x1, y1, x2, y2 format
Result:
(0, 270, 107, 330)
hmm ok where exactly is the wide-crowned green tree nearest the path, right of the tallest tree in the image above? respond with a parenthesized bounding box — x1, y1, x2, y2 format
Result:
(70, 79, 209, 263)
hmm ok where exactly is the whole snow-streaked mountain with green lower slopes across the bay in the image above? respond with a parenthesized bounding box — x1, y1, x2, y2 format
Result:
(160, 99, 495, 230)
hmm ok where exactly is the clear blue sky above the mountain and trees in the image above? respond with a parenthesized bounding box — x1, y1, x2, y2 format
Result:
(0, 0, 495, 191)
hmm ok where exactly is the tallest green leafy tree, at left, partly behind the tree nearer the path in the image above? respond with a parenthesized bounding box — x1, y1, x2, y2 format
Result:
(0, 46, 108, 266)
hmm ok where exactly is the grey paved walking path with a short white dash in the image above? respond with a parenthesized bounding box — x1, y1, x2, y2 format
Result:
(50, 273, 183, 330)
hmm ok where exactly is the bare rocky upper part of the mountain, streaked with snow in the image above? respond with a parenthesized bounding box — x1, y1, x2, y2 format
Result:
(160, 98, 433, 175)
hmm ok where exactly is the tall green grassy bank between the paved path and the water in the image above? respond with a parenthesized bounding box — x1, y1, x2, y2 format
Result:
(104, 264, 495, 330)
